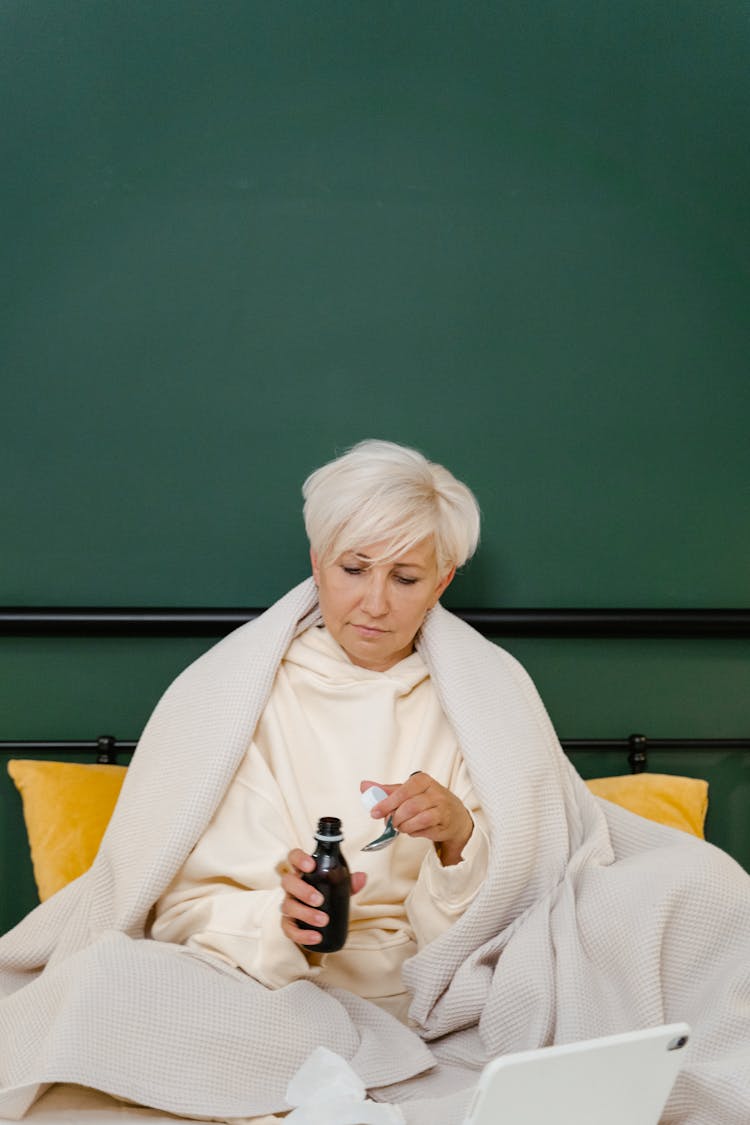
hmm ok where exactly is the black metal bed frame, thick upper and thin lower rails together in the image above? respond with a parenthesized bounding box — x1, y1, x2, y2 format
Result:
(0, 608, 750, 773)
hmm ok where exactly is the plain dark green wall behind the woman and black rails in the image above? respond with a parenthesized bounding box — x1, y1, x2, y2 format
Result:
(0, 0, 750, 918)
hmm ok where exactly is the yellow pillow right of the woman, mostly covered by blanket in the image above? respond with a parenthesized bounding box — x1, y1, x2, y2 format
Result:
(586, 774, 708, 839)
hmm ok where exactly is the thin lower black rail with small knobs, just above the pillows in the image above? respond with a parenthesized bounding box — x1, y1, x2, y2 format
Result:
(0, 735, 750, 773)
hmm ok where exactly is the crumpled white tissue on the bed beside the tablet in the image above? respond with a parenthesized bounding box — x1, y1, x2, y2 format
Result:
(284, 1047, 404, 1125)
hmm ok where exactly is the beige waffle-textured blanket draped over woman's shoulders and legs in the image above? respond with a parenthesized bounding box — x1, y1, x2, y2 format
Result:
(0, 581, 750, 1125)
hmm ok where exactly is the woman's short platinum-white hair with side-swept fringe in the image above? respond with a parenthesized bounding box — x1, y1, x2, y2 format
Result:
(302, 439, 479, 575)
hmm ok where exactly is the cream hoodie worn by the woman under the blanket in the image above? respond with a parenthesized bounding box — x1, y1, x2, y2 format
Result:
(151, 626, 488, 1015)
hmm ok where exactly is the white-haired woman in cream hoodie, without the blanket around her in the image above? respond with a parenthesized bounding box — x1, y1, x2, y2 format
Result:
(151, 441, 488, 1020)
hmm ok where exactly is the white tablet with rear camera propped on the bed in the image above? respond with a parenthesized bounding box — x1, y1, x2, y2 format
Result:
(464, 1024, 690, 1125)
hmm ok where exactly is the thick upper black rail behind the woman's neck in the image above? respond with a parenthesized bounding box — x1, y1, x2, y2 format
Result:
(0, 608, 750, 638)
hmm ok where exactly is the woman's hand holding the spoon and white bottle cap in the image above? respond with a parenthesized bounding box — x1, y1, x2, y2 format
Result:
(360, 771, 473, 867)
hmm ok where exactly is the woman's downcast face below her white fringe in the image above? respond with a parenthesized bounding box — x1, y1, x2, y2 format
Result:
(310, 538, 455, 672)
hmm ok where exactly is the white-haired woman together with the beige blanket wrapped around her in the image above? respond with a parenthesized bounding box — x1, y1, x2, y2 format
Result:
(0, 442, 750, 1125)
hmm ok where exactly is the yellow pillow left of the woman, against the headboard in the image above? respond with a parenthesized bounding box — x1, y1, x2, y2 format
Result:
(8, 761, 127, 902)
